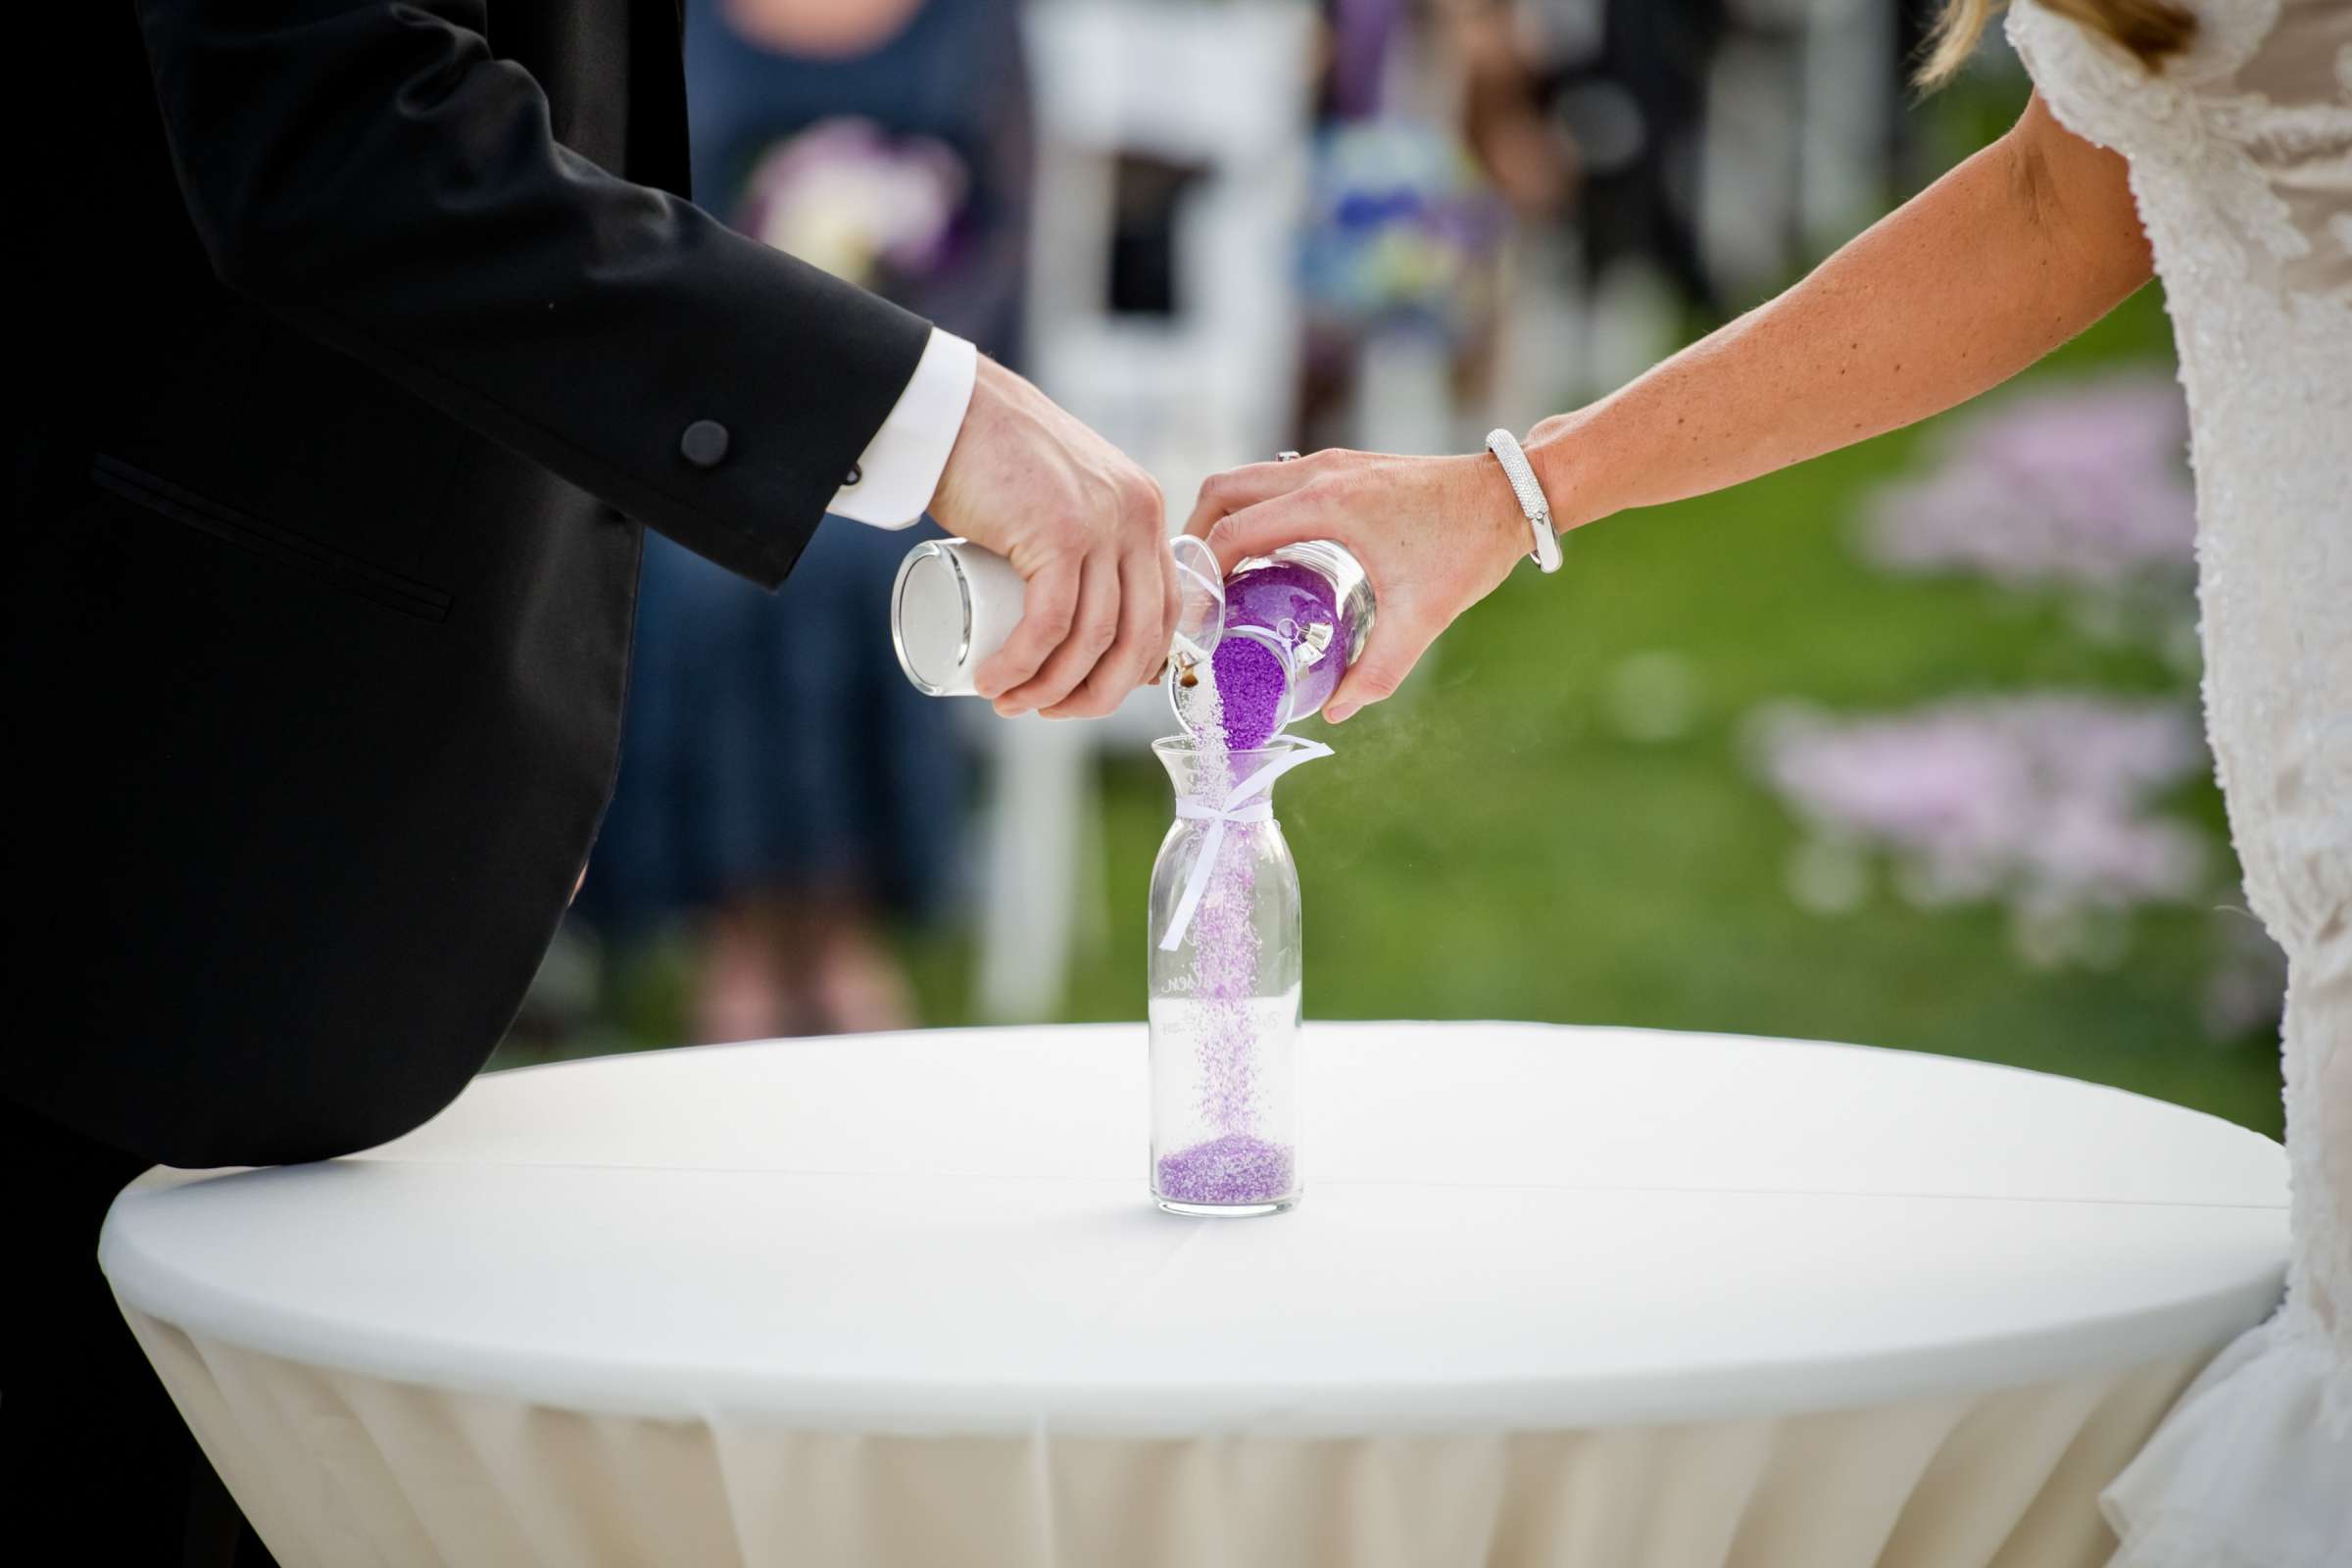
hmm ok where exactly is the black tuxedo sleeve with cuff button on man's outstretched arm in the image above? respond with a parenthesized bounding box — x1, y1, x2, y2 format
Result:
(139, 0, 927, 585)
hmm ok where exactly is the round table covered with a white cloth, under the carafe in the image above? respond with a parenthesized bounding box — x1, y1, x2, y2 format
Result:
(101, 1022, 2286, 1568)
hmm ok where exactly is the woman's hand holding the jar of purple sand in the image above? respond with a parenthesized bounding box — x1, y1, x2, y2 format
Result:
(1186, 452, 1534, 724)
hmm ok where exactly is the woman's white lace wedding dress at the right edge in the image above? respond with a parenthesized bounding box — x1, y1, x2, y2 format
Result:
(2009, 0, 2352, 1568)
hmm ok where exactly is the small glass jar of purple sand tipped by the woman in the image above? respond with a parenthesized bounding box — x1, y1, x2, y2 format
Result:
(1169, 538, 1374, 750)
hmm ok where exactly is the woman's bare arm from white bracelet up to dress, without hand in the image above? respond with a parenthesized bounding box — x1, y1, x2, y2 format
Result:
(1529, 99, 2150, 526)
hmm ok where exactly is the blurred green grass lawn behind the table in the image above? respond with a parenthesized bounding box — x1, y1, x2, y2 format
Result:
(898, 289, 2281, 1136)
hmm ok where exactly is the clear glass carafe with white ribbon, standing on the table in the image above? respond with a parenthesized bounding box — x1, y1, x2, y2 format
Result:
(1148, 736, 1329, 1215)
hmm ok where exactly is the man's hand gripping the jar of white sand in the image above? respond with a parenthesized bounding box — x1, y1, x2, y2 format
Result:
(931, 358, 1176, 719)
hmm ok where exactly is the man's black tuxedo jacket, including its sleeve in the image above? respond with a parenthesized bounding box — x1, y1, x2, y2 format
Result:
(0, 0, 927, 1166)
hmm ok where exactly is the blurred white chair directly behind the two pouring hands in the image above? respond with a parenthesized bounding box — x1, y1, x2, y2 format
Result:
(966, 0, 1317, 1022)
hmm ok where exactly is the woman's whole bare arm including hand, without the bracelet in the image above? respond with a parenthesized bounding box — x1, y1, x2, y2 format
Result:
(1188, 96, 2150, 721)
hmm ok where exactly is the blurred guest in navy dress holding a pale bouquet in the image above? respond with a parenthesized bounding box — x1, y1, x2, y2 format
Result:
(581, 0, 1030, 1039)
